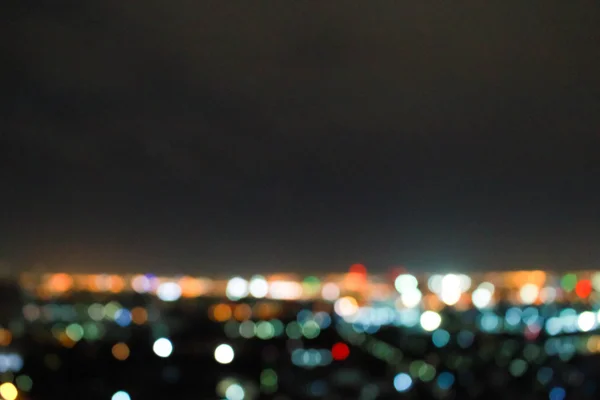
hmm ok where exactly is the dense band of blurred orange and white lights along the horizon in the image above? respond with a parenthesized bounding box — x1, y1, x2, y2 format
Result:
(22, 270, 600, 309)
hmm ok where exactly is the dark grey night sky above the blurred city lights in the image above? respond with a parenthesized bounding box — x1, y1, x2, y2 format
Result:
(0, 0, 600, 273)
